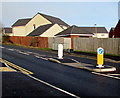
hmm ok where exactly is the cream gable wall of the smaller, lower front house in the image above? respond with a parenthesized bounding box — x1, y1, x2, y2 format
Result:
(40, 24, 63, 37)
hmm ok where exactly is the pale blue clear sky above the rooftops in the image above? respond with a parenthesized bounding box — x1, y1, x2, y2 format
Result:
(0, 1, 118, 31)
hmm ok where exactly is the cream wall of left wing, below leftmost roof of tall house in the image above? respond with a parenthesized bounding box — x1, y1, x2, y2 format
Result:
(12, 26, 26, 36)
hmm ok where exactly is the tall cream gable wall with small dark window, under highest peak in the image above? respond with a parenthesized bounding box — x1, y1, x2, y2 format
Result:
(25, 14, 51, 35)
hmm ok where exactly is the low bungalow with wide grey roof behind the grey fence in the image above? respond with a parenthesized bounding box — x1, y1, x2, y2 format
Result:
(56, 25, 108, 38)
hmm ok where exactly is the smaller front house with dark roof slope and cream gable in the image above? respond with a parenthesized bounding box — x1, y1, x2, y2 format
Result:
(27, 24, 64, 37)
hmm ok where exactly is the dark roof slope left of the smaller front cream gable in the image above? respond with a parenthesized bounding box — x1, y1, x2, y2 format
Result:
(27, 24, 54, 36)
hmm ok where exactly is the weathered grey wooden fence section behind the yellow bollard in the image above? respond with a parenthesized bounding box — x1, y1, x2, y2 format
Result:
(73, 38, 120, 55)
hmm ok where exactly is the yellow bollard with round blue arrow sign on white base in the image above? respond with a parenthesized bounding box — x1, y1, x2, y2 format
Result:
(96, 47, 104, 68)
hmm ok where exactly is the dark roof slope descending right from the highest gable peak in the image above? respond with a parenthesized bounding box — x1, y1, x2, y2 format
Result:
(38, 13, 69, 26)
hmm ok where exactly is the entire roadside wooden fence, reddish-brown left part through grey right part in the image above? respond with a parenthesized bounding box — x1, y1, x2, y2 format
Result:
(2, 36, 120, 55)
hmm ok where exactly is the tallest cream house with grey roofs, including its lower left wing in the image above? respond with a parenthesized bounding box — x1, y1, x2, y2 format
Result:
(12, 13, 69, 36)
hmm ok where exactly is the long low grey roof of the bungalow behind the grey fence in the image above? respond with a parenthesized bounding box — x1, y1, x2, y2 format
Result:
(56, 25, 108, 36)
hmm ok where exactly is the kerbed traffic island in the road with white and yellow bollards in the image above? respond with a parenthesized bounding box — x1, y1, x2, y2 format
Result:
(48, 44, 116, 72)
